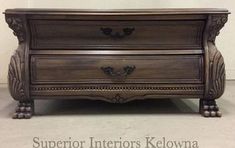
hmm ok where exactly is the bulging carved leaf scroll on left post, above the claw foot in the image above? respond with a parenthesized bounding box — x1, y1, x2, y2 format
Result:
(8, 50, 25, 100)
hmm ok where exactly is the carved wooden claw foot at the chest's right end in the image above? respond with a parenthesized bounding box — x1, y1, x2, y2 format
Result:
(200, 99, 222, 117)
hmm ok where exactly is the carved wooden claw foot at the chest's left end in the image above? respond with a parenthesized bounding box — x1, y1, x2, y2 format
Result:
(13, 101, 34, 119)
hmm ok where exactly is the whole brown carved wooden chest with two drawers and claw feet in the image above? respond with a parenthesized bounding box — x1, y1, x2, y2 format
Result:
(4, 9, 229, 119)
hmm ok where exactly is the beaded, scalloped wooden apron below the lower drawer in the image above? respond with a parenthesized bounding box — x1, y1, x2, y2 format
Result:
(31, 84, 204, 103)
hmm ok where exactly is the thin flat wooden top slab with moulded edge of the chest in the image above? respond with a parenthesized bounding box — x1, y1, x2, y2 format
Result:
(4, 8, 230, 15)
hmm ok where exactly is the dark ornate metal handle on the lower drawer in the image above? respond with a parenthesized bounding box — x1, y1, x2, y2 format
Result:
(101, 65, 135, 78)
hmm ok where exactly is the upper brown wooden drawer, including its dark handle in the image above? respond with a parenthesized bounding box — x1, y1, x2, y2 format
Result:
(29, 20, 205, 49)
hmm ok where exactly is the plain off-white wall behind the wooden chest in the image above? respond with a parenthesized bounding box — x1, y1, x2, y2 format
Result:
(0, 0, 235, 83)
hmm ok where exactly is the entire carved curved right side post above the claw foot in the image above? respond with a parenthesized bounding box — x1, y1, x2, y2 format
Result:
(205, 14, 228, 99)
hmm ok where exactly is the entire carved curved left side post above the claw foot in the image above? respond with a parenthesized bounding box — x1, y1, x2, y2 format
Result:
(6, 15, 27, 100)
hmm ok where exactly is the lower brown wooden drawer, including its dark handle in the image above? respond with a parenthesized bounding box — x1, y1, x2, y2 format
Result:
(30, 55, 204, 84)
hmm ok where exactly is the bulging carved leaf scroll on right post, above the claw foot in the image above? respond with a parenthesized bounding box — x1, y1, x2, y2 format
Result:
(209, 44, 225, 99)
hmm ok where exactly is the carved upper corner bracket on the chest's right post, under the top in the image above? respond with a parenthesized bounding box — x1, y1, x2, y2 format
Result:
(208, 14, 228, 43)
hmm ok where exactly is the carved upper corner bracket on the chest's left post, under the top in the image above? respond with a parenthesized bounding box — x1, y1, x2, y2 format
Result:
(6, 15, 26, 43)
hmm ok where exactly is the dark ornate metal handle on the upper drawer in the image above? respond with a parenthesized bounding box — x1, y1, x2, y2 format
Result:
(100, 27, 135, 39)
